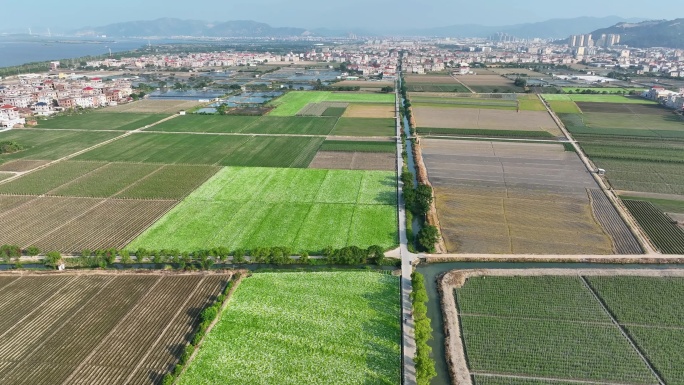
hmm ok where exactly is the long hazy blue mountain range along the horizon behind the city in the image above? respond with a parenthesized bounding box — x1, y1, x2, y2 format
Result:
(71, 16, 643, 39)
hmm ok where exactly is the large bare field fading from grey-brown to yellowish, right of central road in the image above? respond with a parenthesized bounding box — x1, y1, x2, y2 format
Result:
(421, 139, 613, 255)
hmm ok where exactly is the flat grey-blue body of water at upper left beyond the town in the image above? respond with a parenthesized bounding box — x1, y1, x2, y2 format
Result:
(0, 38, 147, 67)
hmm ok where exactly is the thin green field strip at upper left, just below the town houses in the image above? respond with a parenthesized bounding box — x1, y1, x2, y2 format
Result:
(38, 112, 170, 131)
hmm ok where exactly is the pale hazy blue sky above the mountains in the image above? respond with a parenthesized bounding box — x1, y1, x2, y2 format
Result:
(0, 0, 684, 30)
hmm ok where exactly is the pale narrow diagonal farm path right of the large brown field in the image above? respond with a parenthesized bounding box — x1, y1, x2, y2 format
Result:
(537, 95, 657, 254)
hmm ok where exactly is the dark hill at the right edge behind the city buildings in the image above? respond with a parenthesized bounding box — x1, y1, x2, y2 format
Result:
(592, 19, 684, 48)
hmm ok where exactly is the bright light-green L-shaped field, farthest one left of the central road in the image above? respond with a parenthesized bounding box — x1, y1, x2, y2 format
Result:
(269, 91, 395, 116)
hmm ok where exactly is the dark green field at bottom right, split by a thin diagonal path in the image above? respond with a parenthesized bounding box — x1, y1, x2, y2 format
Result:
(454, 270, 684, 385)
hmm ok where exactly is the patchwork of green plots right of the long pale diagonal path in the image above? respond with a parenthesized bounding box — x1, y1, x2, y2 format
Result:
(544, 95, 684, 249)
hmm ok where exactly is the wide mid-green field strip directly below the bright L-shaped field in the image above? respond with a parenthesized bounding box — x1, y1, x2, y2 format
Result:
(147, 115, 337, 135)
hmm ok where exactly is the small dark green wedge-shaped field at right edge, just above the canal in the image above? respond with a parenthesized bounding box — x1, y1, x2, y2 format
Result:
(624, 200, 684, 254)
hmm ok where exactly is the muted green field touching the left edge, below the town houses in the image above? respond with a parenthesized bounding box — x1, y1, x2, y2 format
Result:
(0, 130, 119, 164)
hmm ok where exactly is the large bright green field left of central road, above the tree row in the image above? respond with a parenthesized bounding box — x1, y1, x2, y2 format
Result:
(128, 167, 397, 253)
